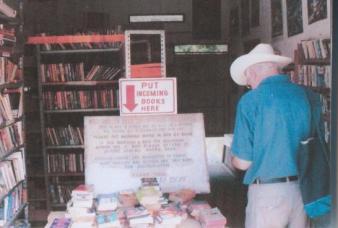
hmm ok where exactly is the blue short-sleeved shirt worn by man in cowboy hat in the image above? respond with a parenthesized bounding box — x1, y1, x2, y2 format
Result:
(231, 75, 310, 184)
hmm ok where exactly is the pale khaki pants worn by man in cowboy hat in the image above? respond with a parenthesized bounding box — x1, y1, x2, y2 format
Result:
(245, 181, 310, 228)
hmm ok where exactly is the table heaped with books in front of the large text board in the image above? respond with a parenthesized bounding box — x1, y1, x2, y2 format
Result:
(45, 178, 226, 228)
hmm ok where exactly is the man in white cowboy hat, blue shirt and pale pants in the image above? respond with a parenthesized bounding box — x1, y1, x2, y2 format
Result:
(230, 44, 310, 228)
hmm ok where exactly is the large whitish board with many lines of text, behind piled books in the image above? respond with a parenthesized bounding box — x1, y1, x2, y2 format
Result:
(84, 113, 210, 194)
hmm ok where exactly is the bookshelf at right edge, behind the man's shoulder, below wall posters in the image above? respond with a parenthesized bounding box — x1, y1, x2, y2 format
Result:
(290, 38, 332, 142)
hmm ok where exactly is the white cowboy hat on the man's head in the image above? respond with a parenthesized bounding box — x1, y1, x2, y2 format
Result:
(230, 44, 292, 85)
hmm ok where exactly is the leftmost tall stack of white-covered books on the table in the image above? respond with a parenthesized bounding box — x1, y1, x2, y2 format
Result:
(67, 185, 96, 228)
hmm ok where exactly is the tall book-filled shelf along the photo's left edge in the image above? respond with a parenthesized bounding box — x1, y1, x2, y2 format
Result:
(0, 0, 28, 227)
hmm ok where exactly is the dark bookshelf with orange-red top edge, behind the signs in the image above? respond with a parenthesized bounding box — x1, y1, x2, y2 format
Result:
(28, 34, 124, 211)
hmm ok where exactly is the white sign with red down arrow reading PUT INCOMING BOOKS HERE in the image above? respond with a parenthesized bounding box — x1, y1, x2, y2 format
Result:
(119, 78, 177, 116)
